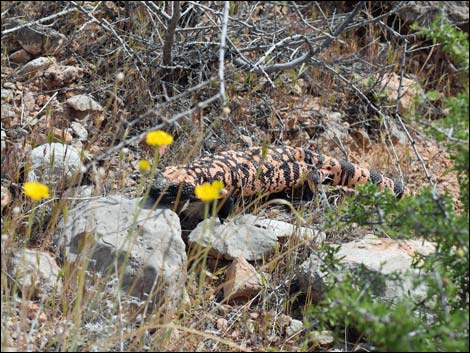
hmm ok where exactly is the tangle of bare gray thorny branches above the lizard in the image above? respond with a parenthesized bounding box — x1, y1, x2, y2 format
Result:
(2, 1, 432, 190)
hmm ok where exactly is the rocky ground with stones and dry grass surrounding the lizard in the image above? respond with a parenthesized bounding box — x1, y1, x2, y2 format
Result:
(1, 2, 468, 351)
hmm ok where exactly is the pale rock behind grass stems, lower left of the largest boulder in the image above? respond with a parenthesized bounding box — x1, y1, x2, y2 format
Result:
(10, 249, 62, 296)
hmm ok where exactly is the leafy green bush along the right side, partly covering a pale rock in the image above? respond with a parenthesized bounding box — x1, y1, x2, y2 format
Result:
(308, 18, 470, 351)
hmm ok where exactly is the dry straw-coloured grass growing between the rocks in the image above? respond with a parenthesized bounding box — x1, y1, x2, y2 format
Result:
(1, 2, 458, 351)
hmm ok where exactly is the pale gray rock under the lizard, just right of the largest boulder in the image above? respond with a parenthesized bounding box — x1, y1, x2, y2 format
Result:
(189, 215, 277, 261)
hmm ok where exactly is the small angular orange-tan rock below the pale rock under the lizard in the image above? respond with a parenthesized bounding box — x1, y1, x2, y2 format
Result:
(224, 257, 263, 301)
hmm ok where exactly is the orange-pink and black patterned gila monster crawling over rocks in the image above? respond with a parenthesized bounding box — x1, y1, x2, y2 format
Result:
(150, 146, 407, 218)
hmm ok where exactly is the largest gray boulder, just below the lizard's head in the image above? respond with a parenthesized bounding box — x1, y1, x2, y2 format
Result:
(53, 195, 186, 304)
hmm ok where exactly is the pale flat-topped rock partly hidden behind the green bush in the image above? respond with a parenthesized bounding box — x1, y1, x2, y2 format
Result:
(297, 236, 434, 302)
